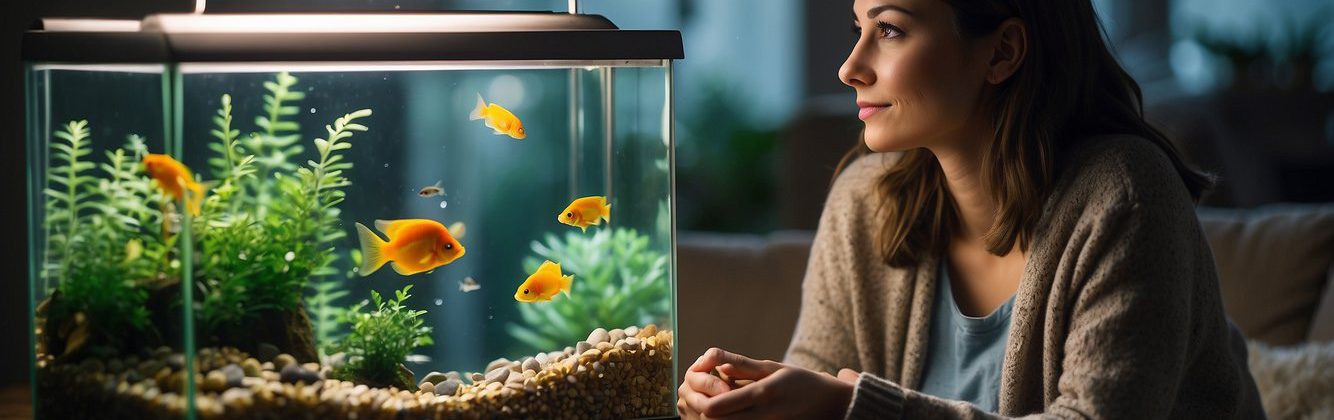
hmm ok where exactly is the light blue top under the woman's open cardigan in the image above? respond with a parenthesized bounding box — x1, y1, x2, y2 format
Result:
(920, 259, 1014, 412)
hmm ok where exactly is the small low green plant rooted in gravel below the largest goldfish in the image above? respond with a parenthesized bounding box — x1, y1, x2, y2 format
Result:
(328, 284, 434, 389)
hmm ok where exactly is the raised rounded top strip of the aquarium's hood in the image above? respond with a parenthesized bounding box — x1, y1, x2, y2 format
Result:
(144, 13, 615, 33)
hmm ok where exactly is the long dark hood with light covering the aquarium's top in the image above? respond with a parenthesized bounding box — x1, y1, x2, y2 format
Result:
(23, 12, 683, 63)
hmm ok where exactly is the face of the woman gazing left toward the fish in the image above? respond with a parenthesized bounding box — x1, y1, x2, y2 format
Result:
(839, 0, 987, 152)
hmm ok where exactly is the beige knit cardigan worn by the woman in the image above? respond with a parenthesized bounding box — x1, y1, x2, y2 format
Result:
(786, 136, 1265, 419)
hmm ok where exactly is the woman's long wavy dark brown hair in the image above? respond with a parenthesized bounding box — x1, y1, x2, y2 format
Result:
(835, 0, 1213, 267)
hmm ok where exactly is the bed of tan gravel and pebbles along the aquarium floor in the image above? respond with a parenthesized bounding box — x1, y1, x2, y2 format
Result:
(37, 324, 676, 419)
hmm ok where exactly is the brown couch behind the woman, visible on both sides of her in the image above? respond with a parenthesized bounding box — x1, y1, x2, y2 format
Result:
(676, 204, 1334, 417)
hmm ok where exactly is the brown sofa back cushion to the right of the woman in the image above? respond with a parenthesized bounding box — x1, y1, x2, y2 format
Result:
(1198, 204, 1334, 345)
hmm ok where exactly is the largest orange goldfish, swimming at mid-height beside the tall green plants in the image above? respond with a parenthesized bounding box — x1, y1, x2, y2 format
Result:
(356, 219, 464, 277)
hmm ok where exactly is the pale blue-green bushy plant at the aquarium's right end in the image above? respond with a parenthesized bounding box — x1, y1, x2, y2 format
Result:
(506, 228, 671, 352)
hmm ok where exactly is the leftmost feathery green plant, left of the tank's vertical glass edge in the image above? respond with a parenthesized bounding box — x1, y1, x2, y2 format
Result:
(43, 120, 173, 353)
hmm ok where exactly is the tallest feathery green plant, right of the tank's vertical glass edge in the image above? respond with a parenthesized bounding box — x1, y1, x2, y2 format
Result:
(196, 73, 371, 331)
